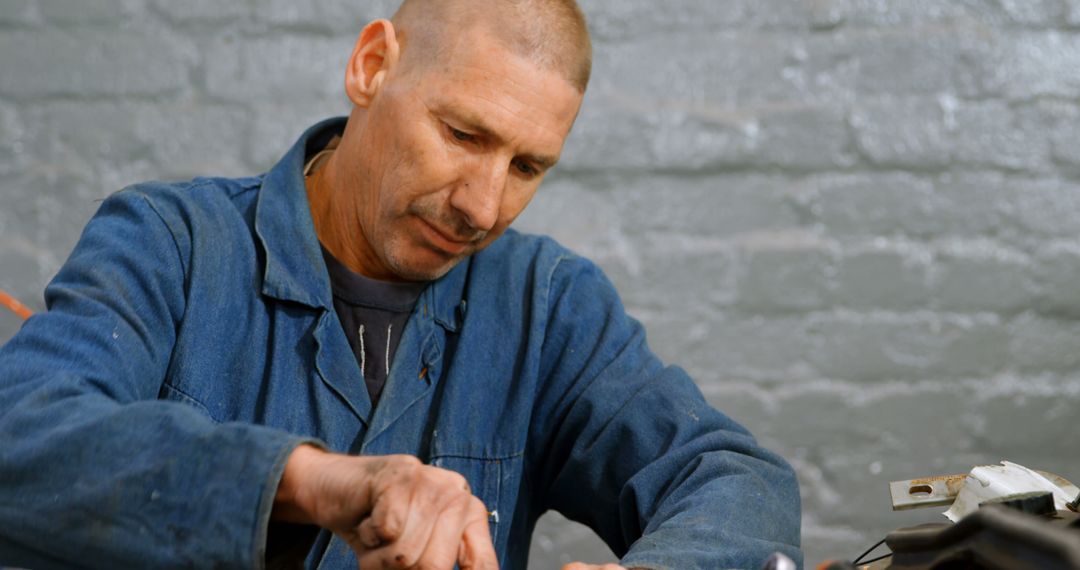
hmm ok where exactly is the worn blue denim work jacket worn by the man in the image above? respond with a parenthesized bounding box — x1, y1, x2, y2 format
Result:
(0, 120, 799, 570)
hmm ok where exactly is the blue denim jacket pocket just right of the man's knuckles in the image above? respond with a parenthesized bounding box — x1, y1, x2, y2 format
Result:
(431, 453, 523, 546)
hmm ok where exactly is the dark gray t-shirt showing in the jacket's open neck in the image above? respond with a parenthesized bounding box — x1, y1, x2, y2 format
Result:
(322, 243, 428, 408)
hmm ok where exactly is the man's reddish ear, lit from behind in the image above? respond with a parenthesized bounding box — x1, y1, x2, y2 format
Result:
(345, 19, 401, 107)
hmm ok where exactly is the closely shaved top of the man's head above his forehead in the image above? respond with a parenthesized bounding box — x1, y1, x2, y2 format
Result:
(392, 0, 592, 93)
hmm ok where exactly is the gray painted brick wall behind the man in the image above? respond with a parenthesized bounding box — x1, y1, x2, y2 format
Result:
(0, 0, 1080, 568)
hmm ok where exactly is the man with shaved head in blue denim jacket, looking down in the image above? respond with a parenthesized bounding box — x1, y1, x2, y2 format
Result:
(0, 0, 799, 569)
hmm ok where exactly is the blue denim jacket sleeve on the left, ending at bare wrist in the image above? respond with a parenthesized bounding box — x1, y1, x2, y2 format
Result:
(0, 190, 315, 568)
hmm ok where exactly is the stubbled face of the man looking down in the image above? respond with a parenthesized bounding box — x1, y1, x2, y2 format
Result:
(348, 30, 581, 281)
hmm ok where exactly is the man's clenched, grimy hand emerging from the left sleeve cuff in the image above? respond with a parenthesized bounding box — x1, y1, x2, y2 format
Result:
(271, 446, 498, 570)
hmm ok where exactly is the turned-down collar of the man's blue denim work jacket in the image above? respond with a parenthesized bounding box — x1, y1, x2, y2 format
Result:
(255, 117, 471, 331)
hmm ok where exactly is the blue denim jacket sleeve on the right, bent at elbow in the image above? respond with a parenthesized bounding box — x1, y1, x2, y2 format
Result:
(534, 256, 801, 570)
